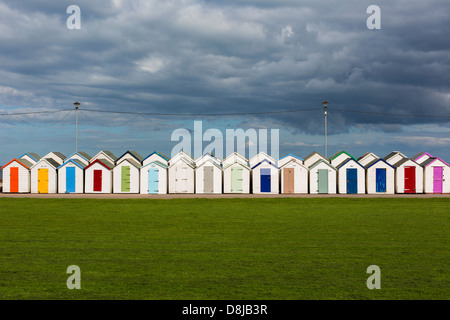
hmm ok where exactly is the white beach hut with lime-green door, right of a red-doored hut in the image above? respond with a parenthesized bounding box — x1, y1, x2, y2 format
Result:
(113, 157, 141, 193)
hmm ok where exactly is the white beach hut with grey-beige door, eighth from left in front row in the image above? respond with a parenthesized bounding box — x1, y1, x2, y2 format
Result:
(195, 153, 223, 193)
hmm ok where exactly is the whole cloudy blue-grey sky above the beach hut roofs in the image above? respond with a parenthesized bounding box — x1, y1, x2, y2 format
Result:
(0, 0, 450, 165)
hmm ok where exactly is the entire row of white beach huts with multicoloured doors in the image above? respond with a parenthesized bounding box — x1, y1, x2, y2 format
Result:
(2, 151, 450, 194)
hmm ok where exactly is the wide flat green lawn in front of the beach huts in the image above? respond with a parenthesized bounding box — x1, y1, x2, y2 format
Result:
(0, 198, 450, 300)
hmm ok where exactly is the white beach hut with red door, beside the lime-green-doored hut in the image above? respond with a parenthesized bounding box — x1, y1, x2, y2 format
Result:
(84, 159, 114, 193)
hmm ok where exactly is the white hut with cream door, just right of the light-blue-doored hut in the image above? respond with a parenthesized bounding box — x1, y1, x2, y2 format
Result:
(168, 151, 195, 193)
